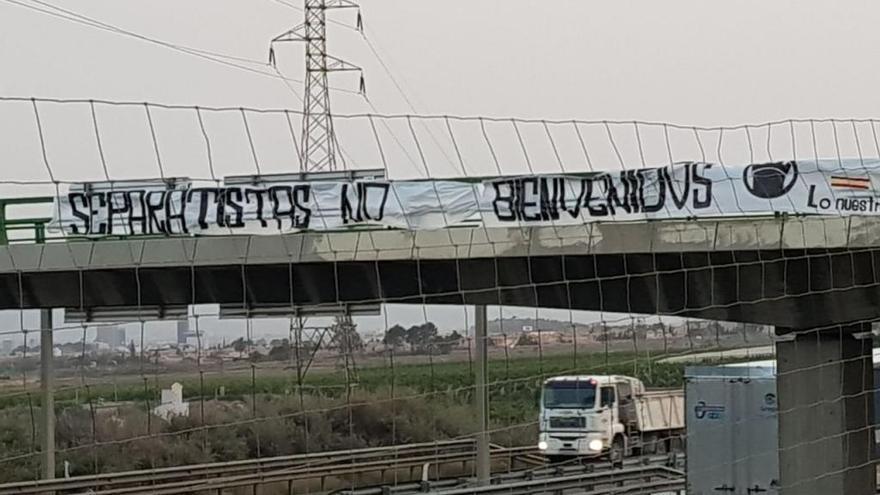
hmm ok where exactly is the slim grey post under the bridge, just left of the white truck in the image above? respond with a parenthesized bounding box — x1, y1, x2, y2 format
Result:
(474, 306, 492, 485)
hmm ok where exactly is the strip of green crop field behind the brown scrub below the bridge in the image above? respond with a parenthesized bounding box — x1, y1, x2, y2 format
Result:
(0, 352, 683, 409)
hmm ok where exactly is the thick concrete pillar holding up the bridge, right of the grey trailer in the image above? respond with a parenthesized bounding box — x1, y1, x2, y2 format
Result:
(765, 323, 876, 495)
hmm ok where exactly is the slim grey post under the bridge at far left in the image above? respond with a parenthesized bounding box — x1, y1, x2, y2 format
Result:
(40, 309, 55, 480)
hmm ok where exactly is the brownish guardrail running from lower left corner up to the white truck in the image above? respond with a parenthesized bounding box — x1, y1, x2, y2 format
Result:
(0, 440, 543, 495)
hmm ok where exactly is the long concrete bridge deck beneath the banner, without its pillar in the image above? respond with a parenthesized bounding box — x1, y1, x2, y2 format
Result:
(0, 216, 880, 328)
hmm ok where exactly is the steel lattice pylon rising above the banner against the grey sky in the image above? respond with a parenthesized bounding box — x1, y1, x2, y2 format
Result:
(269, 0, 364, 172)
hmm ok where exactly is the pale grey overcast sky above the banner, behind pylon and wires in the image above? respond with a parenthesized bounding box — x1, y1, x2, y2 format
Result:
(0, 0, 880, 186)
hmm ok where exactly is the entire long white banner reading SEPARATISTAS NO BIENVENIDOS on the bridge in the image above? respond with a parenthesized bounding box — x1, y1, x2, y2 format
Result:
(50, 160, 880, 237)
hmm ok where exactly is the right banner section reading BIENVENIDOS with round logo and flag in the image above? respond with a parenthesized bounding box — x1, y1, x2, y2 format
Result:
(480, 160, 880, 226)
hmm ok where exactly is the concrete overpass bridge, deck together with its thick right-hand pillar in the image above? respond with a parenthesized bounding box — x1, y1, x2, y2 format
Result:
(0, 199, 880, 494)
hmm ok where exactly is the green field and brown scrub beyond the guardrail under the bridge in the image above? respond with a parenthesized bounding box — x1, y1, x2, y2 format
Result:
(0, 352, 716, 481)
